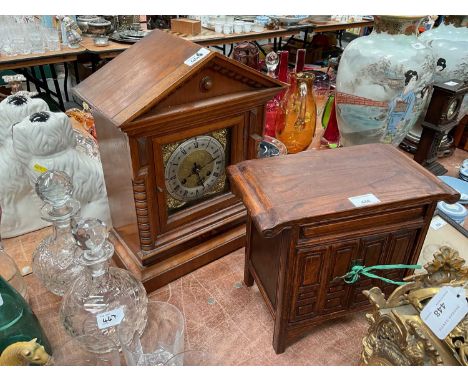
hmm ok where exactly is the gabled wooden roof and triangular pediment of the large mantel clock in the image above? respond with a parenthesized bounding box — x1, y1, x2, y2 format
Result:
(73, 30, 286, 127)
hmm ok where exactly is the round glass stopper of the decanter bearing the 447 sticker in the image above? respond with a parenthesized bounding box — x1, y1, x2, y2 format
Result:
(72, 218, 108, 252)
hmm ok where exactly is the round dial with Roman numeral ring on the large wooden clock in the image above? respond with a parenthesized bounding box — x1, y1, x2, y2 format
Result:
(164, 135, 226, 206)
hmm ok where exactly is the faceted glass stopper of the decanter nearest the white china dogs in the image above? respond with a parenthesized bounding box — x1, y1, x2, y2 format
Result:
(35, 170, 73, 206)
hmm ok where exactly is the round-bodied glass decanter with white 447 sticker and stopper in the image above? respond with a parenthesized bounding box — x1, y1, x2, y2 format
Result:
(60, 219, 148, 353)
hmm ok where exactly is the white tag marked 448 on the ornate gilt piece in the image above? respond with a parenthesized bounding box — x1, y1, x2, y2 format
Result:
(421, 286, 468, 340)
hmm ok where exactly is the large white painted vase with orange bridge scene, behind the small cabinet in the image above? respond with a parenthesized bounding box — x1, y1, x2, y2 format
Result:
(335, 16, 434, 146)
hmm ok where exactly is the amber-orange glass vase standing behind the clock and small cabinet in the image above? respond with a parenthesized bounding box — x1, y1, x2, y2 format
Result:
(276, 72, 317, 154)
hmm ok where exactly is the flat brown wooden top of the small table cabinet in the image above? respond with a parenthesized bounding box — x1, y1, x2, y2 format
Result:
(228, 144, 459, 232)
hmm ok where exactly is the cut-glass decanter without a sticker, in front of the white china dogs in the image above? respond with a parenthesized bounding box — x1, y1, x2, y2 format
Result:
(32, 170, 83, 296)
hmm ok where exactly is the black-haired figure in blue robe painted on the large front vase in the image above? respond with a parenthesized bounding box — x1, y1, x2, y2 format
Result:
(384, 70, 419, 143)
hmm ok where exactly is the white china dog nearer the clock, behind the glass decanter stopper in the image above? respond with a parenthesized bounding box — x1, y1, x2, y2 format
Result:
(13, 111, 110, 236)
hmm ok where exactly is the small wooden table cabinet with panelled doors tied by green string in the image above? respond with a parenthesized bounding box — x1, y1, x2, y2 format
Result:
(228, 144, 459, 353)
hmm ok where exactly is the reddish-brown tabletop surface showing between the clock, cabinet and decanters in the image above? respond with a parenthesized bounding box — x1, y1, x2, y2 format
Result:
(4, 150, 468, 365)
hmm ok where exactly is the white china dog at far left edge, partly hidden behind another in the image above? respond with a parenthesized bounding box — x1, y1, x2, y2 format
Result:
(0, 92, 49, 238)
